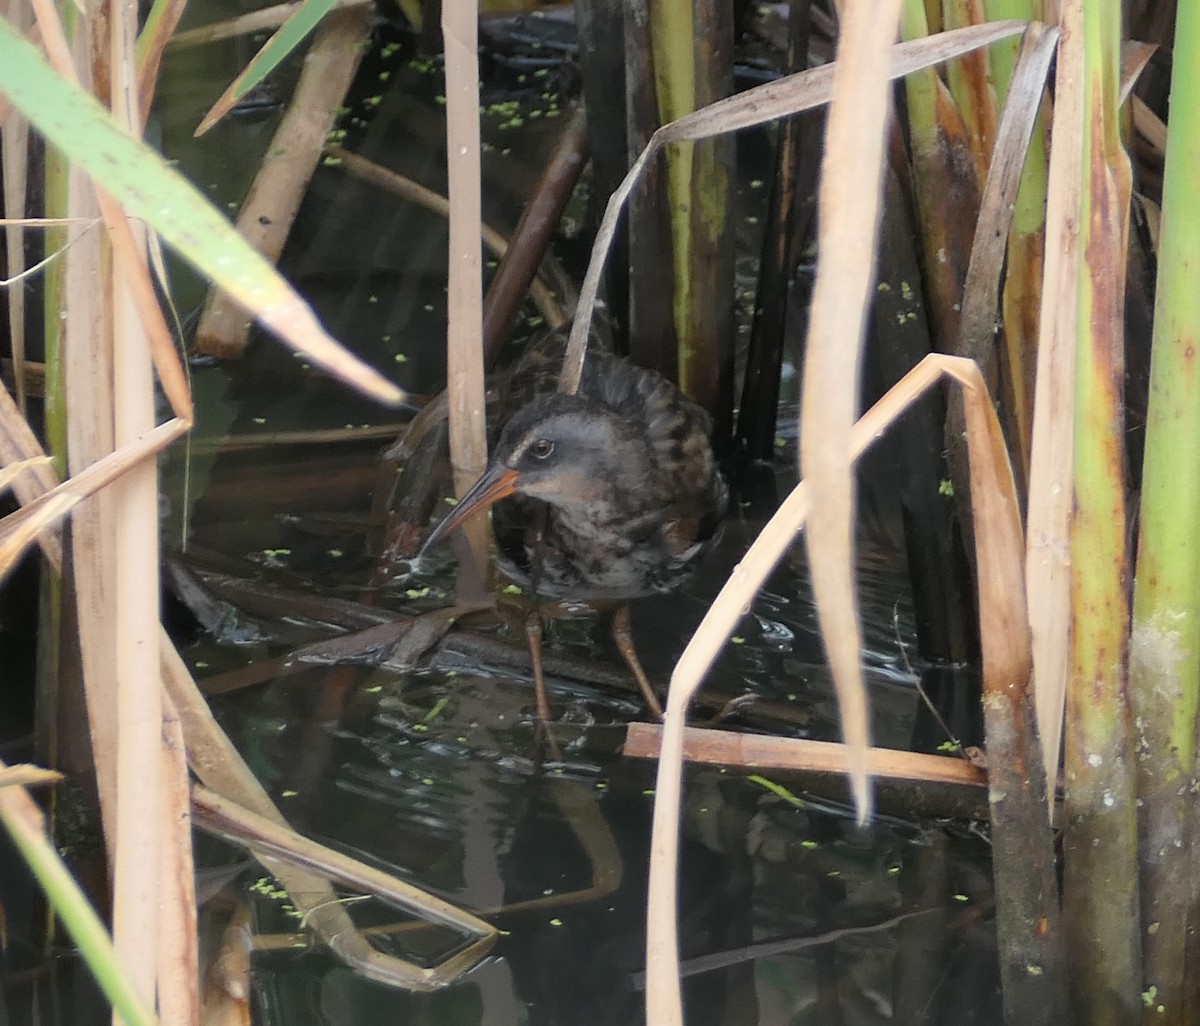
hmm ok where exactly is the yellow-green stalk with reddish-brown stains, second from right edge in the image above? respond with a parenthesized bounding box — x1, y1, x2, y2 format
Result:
(1054, 0, 1142, 1026)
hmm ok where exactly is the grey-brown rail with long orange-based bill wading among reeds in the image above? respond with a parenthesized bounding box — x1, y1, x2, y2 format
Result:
(422, 330, 728, 721)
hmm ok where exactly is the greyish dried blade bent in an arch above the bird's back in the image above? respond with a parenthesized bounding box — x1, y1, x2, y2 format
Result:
(559, 22, 1026, 392)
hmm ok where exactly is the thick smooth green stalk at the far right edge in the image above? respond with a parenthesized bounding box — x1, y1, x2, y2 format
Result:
(1129, 4, 1200, 1026)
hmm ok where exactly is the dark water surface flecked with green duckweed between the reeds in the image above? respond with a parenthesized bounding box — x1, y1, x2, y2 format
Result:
(14, 13, 1000, 1026)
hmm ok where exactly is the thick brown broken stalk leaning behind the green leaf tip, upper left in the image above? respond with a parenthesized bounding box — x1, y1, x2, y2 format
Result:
(196, 6, 371, 358)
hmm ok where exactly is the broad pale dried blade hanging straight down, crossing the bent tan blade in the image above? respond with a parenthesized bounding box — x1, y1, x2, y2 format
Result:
(800, 0, 900, 823)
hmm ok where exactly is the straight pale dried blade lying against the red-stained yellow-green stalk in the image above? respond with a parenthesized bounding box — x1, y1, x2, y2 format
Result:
(1025, 12, 1084, 815)
